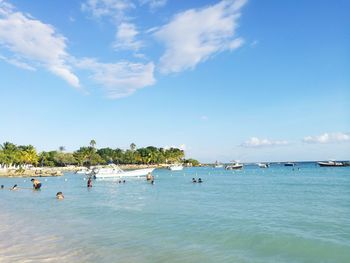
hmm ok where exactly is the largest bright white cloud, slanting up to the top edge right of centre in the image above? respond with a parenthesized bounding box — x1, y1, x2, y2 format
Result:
(155, 0, 246, 73)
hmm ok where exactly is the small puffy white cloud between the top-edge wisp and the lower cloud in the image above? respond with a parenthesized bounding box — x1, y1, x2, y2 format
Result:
(114, 23, 143, 51)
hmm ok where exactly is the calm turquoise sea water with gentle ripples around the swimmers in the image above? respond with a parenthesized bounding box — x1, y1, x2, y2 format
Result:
(0, 164, 350, 263)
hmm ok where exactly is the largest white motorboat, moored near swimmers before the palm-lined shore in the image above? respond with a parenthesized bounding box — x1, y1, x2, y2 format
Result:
(92, 164, 155, 178)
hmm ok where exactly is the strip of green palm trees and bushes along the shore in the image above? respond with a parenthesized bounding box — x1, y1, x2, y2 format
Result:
(0, 140, 199, 167)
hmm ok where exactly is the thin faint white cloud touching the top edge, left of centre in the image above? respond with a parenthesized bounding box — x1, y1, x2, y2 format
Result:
(81, 0, 135, 20)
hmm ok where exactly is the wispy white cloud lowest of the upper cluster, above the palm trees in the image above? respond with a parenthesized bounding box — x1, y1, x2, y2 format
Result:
(77, 59, 155, 99)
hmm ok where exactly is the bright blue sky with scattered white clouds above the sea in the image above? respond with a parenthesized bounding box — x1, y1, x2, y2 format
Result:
(0, 0, 350, 162)
